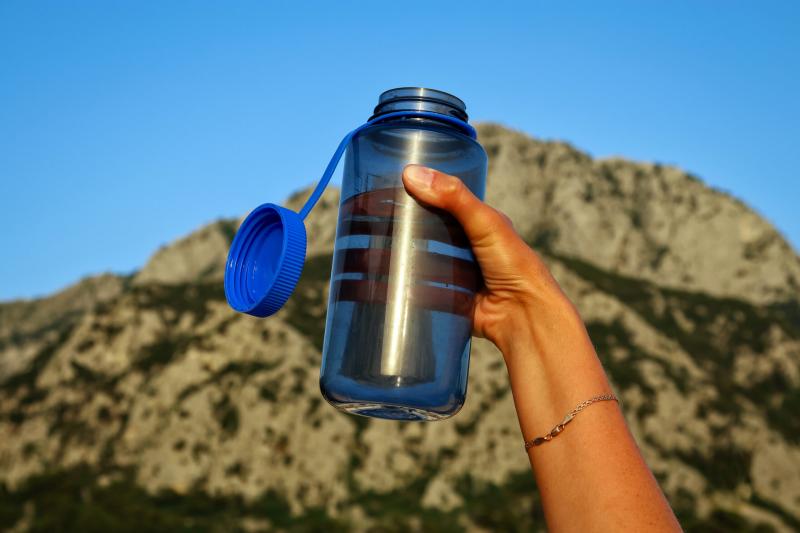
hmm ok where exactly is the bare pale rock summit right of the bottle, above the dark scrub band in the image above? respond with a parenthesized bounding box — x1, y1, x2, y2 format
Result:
(480, 121, 800, 303)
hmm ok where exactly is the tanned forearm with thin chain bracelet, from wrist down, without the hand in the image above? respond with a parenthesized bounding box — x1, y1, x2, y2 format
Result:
(498, 291, 680, 531)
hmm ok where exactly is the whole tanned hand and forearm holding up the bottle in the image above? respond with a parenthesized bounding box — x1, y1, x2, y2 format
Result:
(403, 165, 680, 531)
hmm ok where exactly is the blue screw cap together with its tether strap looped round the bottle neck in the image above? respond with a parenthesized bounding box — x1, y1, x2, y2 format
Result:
(225, 111, 477, 317)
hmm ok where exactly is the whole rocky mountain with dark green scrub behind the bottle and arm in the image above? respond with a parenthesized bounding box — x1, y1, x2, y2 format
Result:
(0, 125, 800, 531)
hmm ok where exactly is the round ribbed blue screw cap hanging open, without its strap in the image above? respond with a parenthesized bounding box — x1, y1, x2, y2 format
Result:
(225, 204, 306, 317)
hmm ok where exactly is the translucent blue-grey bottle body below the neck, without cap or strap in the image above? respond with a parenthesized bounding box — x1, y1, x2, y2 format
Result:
(320, 119, 487, 420)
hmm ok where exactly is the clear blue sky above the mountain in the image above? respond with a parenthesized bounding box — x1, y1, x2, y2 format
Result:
(0, 0, 800, 300)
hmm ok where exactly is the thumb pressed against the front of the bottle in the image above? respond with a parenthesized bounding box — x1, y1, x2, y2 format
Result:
(403, 165, 513, 247)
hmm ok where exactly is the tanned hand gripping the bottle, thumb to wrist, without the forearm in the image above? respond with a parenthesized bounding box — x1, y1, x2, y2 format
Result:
(403, 165, 576, 355)
